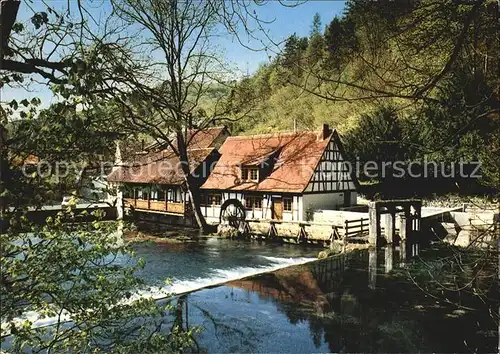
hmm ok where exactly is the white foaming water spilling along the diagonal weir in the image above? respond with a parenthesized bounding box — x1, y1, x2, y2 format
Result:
(2, 256, 316, 332)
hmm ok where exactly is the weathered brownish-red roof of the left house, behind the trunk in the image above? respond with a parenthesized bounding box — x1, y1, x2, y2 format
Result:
(108, 127, 225, 185)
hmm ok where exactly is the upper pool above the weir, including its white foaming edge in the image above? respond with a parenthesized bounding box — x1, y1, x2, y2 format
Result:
(127, 238, 321, 294)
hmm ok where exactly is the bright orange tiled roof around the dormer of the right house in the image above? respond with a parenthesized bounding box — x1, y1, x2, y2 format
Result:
(202, 132, 332, 193)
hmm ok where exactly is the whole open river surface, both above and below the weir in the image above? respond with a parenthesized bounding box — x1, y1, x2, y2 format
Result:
(130, 239, 498, 353)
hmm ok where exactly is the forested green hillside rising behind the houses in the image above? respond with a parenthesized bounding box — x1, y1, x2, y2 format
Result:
(232, 0, 500, 195)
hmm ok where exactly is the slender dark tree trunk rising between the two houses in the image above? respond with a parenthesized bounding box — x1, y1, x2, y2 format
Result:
(177, 132, 208, 232)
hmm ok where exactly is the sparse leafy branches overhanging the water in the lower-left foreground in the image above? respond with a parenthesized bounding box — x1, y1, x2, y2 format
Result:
(0, 212, 192, 353)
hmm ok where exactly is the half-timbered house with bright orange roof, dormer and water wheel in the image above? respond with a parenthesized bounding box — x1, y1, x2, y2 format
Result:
(197, 125, 357, 222)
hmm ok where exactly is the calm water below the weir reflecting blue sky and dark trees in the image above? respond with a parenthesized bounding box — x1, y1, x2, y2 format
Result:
(172, 246, 494, 352)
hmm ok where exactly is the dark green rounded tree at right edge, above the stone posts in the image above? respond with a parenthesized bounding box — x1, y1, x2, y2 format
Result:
(415, 73, 500, 161)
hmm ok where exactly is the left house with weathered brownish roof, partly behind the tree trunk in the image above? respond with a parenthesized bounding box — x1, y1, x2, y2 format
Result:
(107, 127, 229, 217)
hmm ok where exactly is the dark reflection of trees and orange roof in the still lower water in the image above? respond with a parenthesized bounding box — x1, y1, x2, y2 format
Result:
(228, 248, 494, 352)
